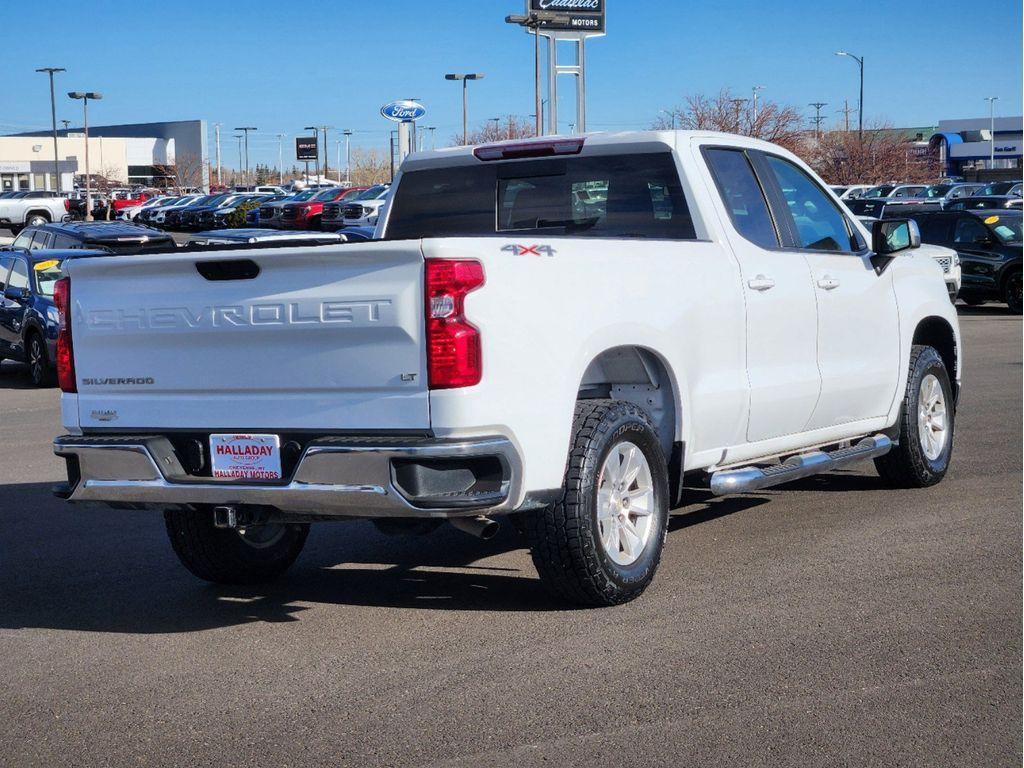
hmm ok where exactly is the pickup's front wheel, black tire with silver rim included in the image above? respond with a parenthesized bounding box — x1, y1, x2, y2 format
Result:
(874, 345, 955, 488)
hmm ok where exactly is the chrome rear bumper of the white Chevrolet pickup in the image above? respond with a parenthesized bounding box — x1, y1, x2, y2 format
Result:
(53, 435, 522, 517)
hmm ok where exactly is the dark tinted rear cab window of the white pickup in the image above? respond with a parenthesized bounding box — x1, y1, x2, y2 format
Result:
(385, 150, 696, 240)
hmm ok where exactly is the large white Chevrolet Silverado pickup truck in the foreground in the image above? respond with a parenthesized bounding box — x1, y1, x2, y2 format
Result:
(54, 131, 963, 605)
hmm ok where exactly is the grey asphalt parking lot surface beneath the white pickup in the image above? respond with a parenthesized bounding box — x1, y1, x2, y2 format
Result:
(0, 305, 1022, 768)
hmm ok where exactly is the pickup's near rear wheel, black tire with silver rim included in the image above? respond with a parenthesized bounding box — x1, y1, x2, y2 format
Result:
(524, 399, 669, 605)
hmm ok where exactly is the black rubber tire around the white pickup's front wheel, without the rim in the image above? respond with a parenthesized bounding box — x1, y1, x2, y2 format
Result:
(874, 345, 955, 488)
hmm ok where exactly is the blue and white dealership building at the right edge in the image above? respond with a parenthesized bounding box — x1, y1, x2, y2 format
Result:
(928, 117, 1024, 178)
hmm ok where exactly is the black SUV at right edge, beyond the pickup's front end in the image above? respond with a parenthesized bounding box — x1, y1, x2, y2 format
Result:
(884, 209, 1021, 314)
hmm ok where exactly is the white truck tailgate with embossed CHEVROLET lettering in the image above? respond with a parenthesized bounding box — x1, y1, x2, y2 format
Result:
(66, 242, 429, 432)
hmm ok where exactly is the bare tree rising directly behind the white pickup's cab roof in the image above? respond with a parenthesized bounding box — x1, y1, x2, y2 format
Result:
(652, 88, 804, 152)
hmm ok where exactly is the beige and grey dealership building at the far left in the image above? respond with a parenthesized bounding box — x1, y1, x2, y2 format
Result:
(0, 120, 210, 191)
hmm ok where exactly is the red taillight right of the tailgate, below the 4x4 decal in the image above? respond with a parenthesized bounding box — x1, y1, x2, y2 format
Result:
(426, 259, 483, 389)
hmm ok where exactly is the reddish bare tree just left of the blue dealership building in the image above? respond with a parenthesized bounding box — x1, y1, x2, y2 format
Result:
(805, 124, 939, 184)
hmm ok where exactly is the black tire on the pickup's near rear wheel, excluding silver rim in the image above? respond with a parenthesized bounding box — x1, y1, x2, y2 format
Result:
(523, 399, 669, 606)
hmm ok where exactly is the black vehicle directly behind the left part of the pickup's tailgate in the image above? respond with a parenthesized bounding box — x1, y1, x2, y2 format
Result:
(11, 221, 175, 253)
